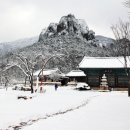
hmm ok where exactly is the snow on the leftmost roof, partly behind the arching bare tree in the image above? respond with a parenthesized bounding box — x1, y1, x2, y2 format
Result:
(33, 68, 62, 76)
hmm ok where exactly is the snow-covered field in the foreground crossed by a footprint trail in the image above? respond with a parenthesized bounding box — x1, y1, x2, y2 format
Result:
(0, 86, 130, 130)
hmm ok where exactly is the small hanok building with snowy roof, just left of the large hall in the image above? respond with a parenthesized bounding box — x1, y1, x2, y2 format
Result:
(66, 70, 86, 82)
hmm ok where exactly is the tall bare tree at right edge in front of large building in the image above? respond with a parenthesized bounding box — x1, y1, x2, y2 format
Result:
(111, 20, 130, 96)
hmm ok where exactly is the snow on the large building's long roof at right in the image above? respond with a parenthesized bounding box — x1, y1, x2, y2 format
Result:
(79, 56, 130, 68)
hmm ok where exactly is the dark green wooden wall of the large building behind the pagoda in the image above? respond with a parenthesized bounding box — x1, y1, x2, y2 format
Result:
(82, 69, 130, 88)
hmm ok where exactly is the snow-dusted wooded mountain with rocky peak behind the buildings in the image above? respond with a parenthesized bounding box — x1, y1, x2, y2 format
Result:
(0, 14, 114, 80)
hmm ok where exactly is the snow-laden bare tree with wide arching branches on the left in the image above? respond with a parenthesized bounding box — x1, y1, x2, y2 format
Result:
(3, 54, 66, 93)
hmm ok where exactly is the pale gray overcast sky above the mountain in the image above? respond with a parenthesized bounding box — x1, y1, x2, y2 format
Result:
(0, 0, 129, 42)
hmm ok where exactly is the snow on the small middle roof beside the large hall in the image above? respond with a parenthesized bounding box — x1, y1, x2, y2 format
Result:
(66, 70, 86, 77)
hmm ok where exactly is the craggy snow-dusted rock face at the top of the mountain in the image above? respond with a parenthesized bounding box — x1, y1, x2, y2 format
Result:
(39, 14, 95, 41)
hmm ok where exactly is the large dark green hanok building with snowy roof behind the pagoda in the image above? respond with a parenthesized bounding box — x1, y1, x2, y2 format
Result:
(79, 56, 130, 88)
